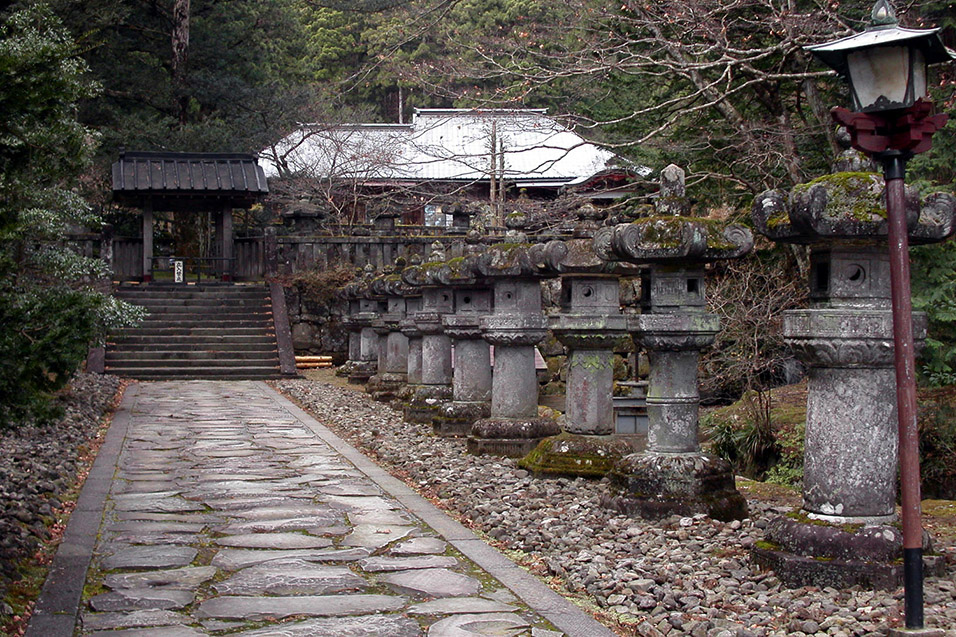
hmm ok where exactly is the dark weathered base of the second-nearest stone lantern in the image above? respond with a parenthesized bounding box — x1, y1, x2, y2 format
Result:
(605, 452, 747, 521)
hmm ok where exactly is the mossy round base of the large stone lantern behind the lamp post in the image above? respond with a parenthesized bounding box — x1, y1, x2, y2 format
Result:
(751, 511, 945, 590)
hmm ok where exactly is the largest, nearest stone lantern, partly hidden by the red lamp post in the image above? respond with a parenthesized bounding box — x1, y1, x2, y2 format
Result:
(752, 172, 956, 588)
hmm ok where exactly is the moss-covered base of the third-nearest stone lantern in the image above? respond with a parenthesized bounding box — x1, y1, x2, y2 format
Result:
(518, 432, 634, 478)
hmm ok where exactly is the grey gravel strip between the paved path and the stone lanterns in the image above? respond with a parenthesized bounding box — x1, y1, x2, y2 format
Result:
(277, 380, 956, 637)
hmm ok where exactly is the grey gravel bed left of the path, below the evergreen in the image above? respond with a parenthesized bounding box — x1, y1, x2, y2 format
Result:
(0, 374, 120, 623)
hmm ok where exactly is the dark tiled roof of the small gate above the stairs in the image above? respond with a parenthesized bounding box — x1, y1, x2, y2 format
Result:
(113, 152, 269, 207)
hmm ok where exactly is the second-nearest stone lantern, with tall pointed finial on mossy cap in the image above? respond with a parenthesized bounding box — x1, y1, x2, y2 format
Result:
(594, 165, 753, 520)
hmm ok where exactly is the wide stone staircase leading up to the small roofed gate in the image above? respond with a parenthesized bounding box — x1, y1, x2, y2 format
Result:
(105, 283, 283, 380)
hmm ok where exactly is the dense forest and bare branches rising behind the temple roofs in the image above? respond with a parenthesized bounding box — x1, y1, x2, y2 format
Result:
(11, 0, 956, 201)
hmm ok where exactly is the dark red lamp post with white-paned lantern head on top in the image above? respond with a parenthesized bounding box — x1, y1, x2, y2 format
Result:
(807, 0, 956, 630)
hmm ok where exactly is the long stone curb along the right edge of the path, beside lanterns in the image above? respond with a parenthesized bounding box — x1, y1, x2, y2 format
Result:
(262, 381, 614, 637)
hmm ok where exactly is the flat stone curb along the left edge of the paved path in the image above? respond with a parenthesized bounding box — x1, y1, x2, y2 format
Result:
(24, 385, 138, 637)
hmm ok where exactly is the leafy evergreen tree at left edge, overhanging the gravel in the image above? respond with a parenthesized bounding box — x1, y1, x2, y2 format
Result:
(0, 6, 143, 426)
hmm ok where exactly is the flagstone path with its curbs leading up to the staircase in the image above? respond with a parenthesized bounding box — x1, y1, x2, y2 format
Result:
(27, 381, 610, 637)
